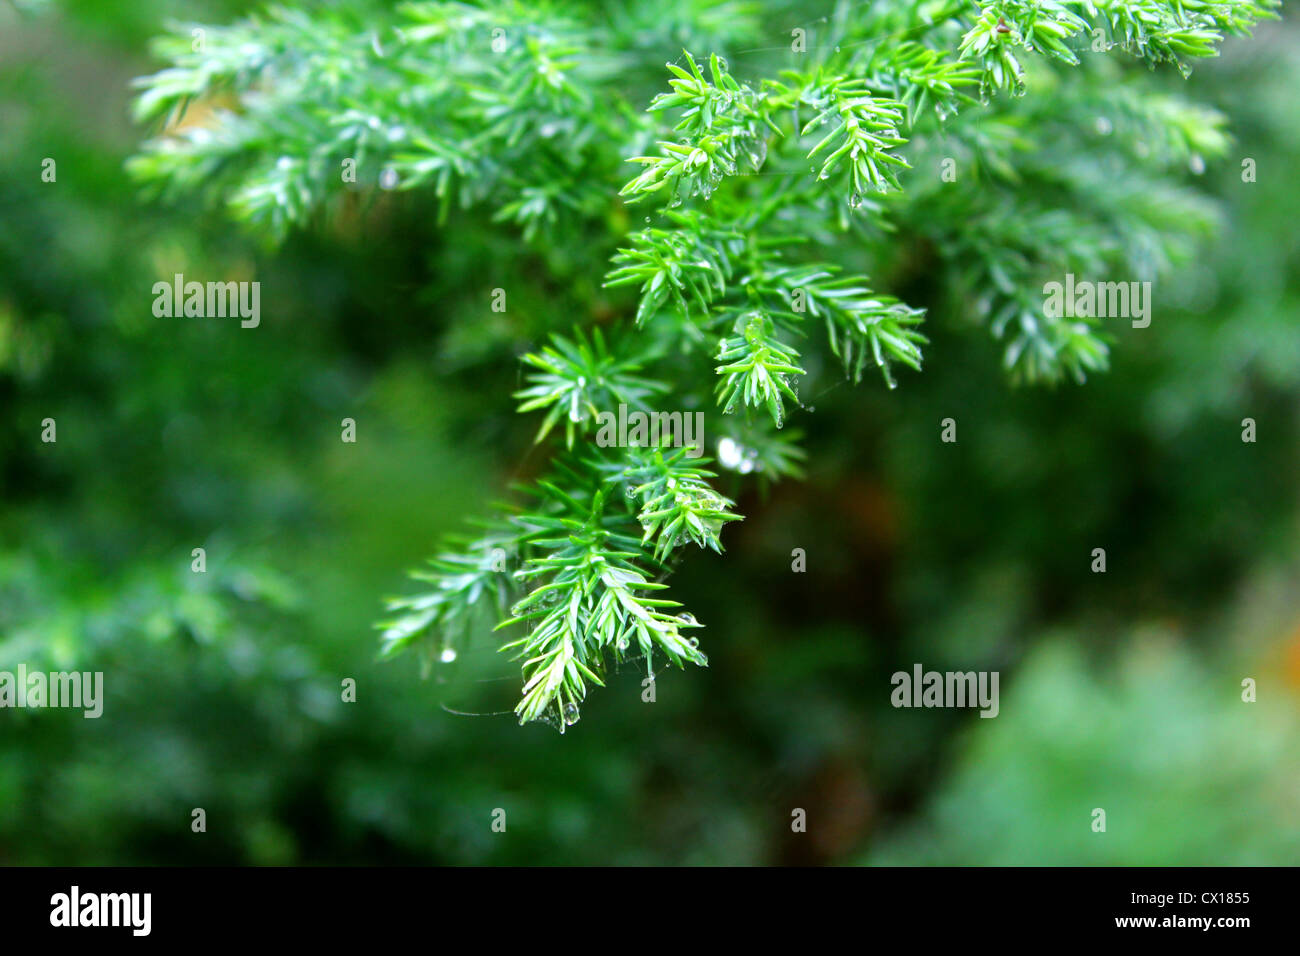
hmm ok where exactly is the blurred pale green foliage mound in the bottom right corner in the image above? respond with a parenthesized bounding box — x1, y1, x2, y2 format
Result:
(868, 632, 1300, 866)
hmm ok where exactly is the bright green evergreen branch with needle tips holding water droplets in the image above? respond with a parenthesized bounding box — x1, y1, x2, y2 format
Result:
(131, 0, 1277, 728)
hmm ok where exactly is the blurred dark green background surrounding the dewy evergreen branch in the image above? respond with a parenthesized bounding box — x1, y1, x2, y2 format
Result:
(0, 0, 1300, 865)
